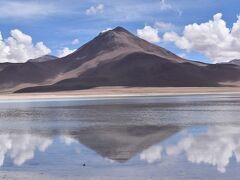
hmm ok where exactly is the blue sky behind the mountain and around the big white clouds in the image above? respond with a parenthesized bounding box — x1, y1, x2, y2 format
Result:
(0, 0, 240, 62)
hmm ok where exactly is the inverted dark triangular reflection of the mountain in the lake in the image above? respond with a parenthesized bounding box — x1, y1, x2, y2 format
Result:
(74, 126, 180, 162)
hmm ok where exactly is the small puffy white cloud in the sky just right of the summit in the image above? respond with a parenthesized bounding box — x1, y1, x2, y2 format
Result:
(137, 26, 160, 43)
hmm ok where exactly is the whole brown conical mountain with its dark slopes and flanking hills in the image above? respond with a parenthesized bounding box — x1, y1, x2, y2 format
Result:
(0, 27, 240, 92)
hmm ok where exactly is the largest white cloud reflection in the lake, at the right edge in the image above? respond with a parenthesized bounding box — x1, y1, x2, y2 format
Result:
(167, 126, 240, 172)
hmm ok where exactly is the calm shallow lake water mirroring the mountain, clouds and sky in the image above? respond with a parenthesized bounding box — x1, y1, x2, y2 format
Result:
(0, 95, 240, 179)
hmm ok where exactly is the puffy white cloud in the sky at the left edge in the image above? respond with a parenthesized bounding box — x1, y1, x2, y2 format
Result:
(0, 29, 51, 63)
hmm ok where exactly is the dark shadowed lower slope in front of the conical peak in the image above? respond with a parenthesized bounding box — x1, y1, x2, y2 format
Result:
(15, 53, 240, 92)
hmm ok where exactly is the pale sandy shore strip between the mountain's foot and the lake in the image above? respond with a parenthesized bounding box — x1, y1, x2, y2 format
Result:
(0, 87, 240, 100)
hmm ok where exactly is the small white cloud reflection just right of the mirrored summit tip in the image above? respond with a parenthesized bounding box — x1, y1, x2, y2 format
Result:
(140, 146, 162, 163)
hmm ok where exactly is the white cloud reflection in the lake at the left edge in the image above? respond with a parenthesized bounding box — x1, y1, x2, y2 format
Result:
(0, 134, 52, 166)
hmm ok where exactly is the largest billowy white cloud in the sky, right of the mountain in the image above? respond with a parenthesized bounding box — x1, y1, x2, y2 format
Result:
(163, 13, 240, 63)
